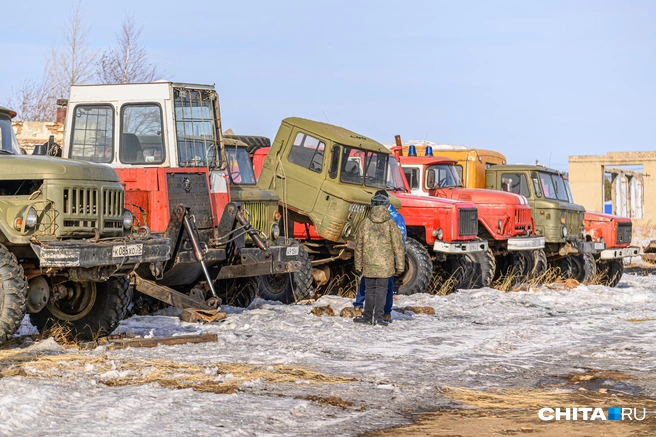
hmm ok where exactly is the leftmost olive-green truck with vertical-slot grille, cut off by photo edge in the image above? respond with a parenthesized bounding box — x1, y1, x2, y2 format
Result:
(0, 107, 170, 342)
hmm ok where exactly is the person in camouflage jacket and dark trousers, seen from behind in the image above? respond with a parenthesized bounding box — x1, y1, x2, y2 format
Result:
(353, 192, 405, 326)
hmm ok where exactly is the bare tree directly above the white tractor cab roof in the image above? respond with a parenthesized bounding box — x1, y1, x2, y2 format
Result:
(96, 15, 163, 83)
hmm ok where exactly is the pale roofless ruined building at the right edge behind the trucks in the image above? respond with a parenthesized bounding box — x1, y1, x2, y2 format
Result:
(569, 152, 656, 225)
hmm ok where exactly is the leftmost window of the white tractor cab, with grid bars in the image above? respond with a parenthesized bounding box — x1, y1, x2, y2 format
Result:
(70, 105, 114, 162)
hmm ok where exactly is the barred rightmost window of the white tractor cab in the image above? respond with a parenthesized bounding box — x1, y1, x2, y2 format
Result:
(174, 89, 218, 167)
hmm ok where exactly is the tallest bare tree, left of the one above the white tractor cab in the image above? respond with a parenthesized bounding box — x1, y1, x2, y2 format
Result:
(48, 1, 98, 98)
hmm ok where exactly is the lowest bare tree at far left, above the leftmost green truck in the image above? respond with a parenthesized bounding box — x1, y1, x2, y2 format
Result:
(9, 77, 57, 121)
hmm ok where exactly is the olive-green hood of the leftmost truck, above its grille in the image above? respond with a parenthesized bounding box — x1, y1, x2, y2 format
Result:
(0, 155, 119, 182)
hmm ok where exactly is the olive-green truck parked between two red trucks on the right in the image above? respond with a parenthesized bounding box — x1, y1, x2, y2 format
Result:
(485, 164, 605, 283)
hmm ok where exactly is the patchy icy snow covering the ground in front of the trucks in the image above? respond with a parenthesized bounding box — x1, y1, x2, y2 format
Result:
(0, 274, 656, 436)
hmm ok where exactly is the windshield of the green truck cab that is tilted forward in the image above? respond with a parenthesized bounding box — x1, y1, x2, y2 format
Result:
(339, 147, 387, 188)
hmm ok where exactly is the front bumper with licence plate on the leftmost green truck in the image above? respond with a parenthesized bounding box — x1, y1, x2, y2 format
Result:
(30, 237, 171, 268)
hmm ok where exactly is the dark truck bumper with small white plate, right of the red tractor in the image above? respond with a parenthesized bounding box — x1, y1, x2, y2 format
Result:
(216, 246, 303, 279)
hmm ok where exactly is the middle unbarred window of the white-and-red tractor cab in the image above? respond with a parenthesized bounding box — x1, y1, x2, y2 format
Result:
(118, 103, 164, 164)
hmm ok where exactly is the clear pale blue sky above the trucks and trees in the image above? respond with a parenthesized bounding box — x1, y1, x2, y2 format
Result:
(0, 0, 656, 170)
